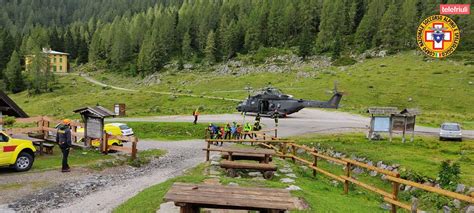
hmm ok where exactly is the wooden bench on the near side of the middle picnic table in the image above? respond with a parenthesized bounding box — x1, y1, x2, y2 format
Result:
(219, 160, 277, 179)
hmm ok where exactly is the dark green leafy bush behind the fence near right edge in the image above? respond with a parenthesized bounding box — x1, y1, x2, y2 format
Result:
(438, 160, 461, 190)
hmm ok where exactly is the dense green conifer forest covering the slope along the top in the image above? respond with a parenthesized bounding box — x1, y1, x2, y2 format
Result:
(0, 0, 474, 93)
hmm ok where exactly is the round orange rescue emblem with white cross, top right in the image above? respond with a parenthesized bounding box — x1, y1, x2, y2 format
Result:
(416, 15, 461, 58)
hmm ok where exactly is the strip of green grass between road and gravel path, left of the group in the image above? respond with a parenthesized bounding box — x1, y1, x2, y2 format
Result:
(127, 122, 207, 140)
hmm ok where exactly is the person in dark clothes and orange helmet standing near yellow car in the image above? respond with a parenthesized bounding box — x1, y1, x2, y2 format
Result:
(56, 119, 72, 172)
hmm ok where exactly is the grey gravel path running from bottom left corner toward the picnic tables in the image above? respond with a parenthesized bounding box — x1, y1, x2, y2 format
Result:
(0, 140, 205, 212)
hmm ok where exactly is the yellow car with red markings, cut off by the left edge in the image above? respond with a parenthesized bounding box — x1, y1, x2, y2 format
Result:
(0, 132, 36, 172)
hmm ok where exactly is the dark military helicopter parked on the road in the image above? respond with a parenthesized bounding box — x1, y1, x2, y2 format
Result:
(236, 85, 343, 117)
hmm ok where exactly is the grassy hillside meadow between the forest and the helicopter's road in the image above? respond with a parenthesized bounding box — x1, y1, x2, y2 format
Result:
(11, 51, 474, 129)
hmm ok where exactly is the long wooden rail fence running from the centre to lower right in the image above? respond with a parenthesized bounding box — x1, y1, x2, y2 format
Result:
(206, 140, 474, 212)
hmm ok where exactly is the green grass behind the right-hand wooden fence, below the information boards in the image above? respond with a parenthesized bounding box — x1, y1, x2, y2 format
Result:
(296, 134, 474, 185)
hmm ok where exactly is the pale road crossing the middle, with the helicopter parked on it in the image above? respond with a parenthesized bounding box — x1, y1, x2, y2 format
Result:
(109, 109, 474, 139)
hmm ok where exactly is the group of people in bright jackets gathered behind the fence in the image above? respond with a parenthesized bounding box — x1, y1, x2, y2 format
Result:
(207, 114, 262, 142)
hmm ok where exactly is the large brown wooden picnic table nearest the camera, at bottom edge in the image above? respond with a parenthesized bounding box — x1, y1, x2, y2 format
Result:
(164, 183, 296, 213)
